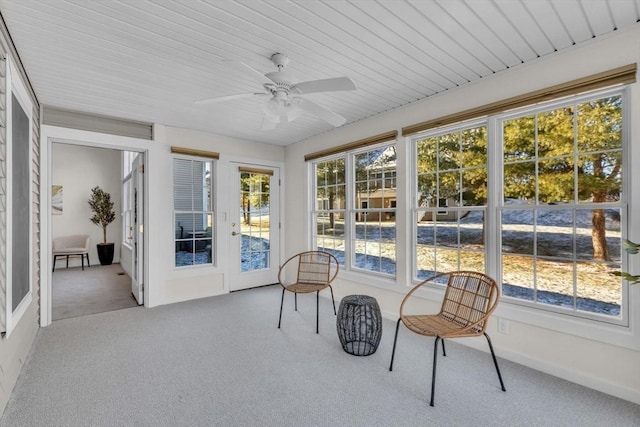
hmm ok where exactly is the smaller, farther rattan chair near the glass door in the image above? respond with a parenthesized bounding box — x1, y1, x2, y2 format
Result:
(278, 251, 339, 333)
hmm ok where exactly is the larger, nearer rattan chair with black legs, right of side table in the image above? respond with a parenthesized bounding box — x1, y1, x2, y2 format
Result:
(389, 271, 506, 406)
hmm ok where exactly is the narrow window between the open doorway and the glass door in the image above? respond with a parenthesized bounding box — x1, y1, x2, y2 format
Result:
(173, 158, 215, 267)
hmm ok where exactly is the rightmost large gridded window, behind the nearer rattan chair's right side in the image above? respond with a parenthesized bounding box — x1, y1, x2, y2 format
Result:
(500, 93, 624, 317)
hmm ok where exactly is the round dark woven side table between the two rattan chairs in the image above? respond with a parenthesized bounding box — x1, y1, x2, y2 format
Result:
(336, 295, 382, 356)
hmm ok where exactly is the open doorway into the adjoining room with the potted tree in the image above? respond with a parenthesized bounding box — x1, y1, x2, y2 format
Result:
(46, 141, 145, 326)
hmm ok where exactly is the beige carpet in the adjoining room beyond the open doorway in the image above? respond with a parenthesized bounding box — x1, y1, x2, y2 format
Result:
(51, 264, 138, 320)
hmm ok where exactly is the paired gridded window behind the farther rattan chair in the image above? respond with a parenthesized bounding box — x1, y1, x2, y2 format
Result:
(312, 145, 396, 276)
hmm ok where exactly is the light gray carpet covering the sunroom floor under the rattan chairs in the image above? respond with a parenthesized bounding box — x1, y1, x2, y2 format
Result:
(0, 287, 640, 427)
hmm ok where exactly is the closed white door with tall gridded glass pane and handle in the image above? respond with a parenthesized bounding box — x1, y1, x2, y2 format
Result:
(229, 163, 280, 291)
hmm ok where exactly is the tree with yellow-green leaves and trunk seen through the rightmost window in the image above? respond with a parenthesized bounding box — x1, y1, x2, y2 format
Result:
(503, 96, 622, 261)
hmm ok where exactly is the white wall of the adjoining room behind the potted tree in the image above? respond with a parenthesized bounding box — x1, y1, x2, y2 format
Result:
(48, 143, 122, 269)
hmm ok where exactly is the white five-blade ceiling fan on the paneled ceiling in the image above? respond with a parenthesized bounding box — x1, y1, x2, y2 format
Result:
(195, 53, 356, 129)
